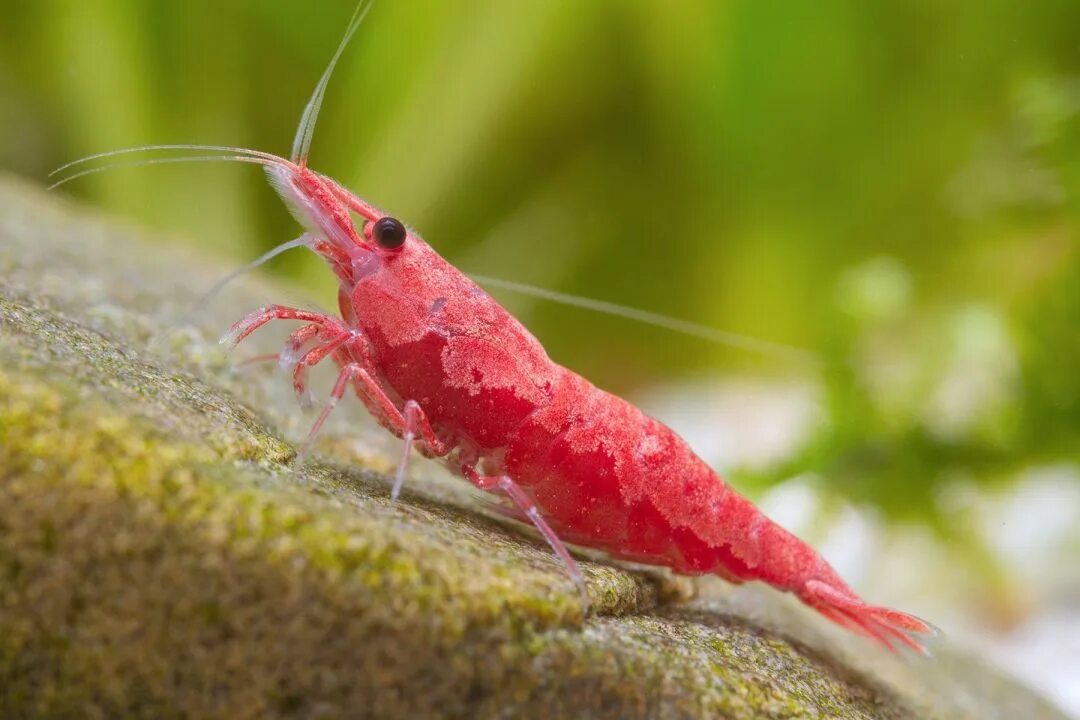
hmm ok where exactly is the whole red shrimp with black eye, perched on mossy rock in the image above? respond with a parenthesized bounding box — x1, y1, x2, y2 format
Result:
(50, 2, 932, 652)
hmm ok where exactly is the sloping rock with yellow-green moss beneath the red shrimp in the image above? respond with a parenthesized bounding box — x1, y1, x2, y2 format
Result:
(0, 177, 1062, 720)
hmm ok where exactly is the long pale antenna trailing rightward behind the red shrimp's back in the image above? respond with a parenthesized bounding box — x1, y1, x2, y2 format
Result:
(469, 273, 821, 366)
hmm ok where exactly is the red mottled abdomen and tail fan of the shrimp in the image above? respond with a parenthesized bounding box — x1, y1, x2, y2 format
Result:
(501, 366, 932, 652)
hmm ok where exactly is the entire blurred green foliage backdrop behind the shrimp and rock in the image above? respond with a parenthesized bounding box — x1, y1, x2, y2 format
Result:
(0, 0, 1080, 527)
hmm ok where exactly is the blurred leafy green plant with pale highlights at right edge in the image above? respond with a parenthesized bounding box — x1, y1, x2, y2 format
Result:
(735, 70, 1080, 624)
